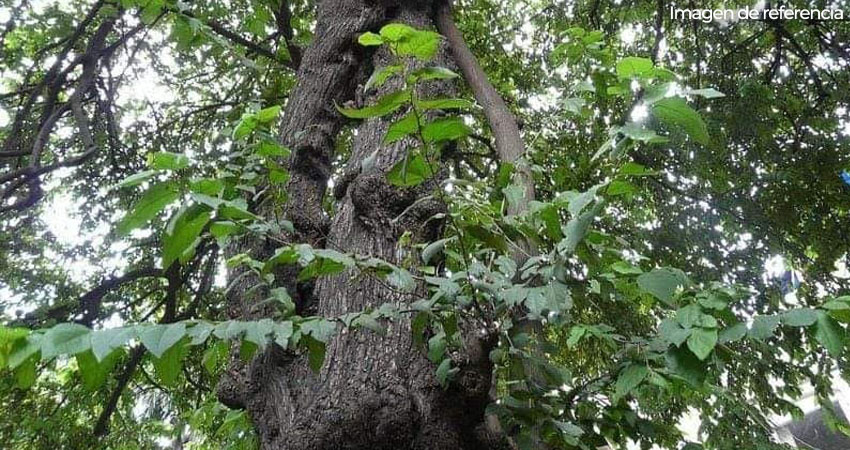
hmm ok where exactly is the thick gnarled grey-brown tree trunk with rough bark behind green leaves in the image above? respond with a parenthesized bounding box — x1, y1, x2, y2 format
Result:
(219, 0, 504, 450)
